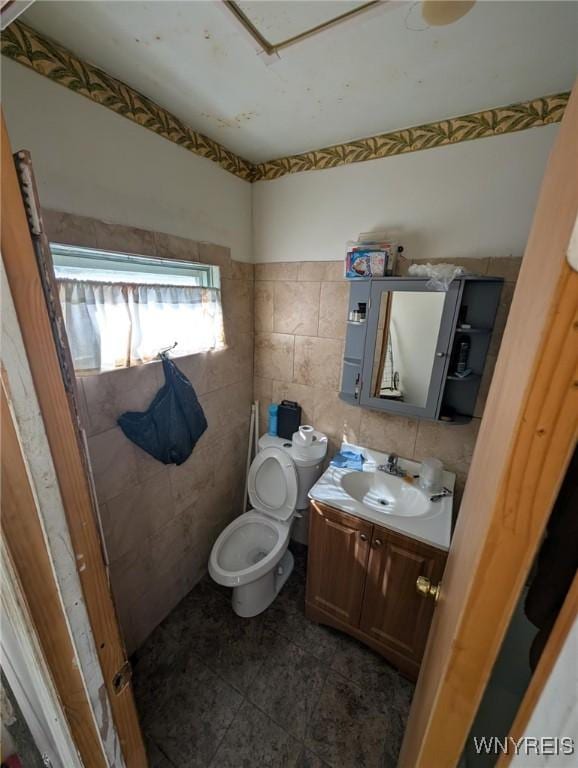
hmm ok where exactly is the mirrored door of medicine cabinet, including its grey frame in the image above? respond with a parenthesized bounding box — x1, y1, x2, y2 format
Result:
(360, 278, 459, 418)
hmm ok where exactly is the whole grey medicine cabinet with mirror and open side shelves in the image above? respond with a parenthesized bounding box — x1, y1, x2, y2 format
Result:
(341, 276, 503, 423)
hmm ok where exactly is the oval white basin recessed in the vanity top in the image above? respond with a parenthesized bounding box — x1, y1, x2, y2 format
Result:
(341, 470, 431, 517)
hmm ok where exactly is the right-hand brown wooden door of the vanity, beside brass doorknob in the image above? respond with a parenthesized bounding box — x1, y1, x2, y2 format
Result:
(361, 525, 447, 664)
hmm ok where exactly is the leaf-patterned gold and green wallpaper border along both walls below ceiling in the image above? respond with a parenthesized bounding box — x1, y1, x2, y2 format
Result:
(2, 21, 570, 182)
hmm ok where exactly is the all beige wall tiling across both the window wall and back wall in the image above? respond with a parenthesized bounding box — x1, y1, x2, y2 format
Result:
(45, 206, 521, 652)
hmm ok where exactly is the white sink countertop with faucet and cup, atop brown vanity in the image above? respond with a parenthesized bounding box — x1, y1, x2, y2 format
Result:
(309, 443, 456, 550)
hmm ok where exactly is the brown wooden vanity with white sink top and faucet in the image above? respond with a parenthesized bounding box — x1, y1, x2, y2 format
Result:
(305, 451, 455, 680)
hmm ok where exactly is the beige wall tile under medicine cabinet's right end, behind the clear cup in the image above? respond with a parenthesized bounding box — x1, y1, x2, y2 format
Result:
(414, 419, 480, 474)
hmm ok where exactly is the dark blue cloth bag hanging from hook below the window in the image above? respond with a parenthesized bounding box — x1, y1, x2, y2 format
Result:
(118, 355, 207, 464)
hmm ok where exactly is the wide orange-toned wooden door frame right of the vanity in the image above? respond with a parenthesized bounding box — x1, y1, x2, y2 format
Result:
(399, 86, 578, 768)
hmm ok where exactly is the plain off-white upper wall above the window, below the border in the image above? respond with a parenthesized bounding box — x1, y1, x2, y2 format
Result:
(2, 57, 252, 261)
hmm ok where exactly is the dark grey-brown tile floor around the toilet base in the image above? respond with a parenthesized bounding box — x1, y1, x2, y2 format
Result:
(133, 544, 413, 768)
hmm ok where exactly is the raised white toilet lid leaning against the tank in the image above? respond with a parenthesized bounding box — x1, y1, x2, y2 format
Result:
(247, 447, 297, 520)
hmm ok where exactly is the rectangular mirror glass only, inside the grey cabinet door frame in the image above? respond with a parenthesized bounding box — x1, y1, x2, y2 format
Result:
(371, 291, 447, 408)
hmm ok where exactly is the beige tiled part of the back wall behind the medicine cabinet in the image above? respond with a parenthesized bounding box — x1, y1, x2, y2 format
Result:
(254, 257, 521, 540)
